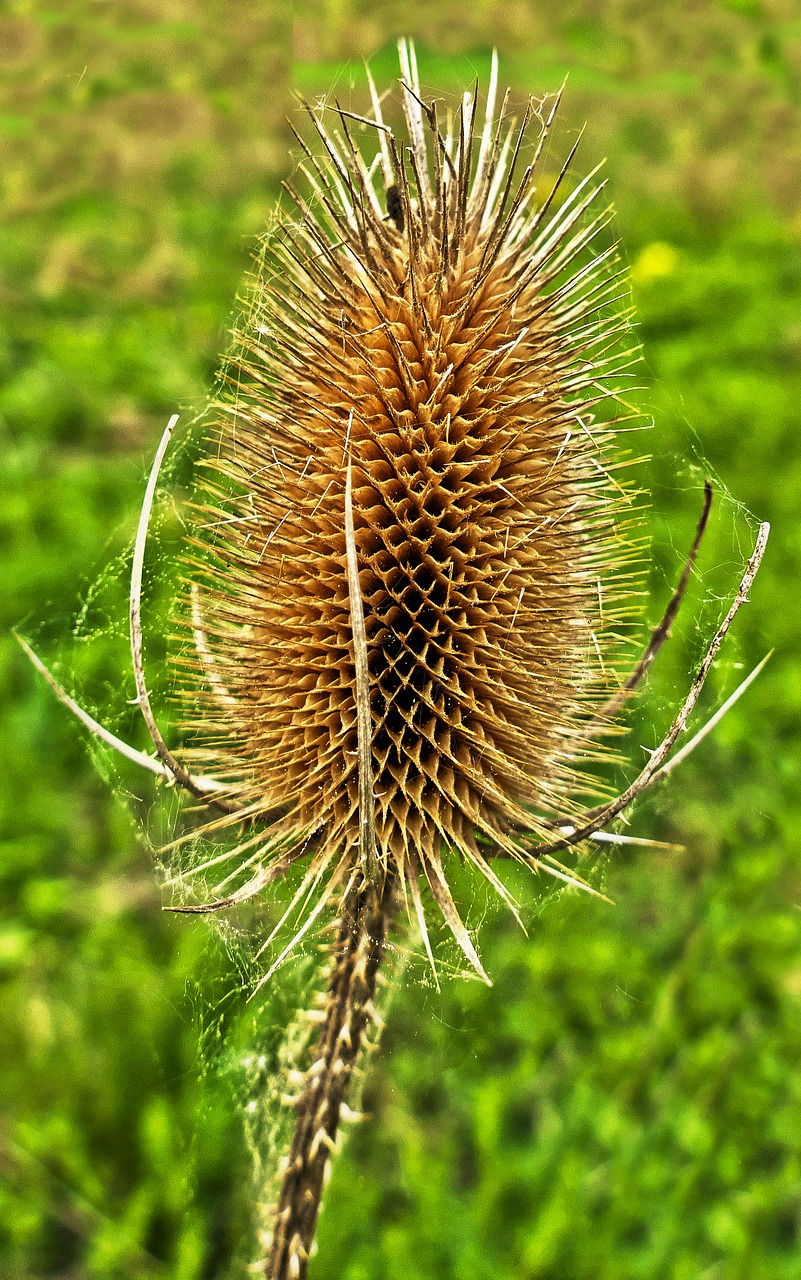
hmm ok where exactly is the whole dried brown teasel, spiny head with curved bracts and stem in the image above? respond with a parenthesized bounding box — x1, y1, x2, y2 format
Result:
(20, 42, 768, 1280)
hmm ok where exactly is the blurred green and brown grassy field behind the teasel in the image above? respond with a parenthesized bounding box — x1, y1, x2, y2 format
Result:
(0, 0, 801, 1280)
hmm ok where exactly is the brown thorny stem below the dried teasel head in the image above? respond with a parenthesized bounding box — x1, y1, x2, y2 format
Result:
(261, 876, 395, 1280)
